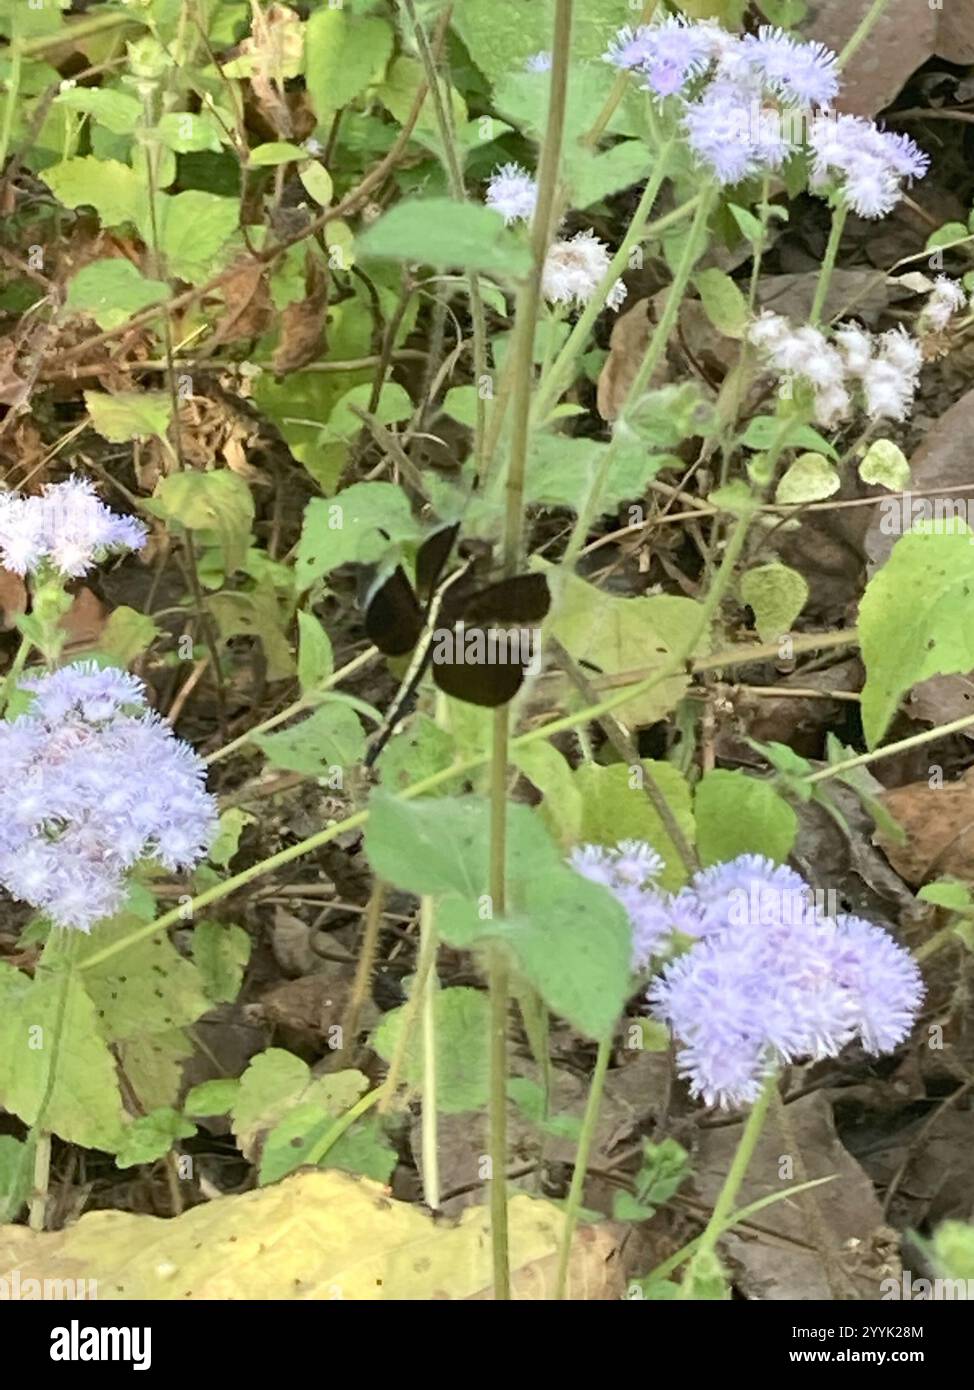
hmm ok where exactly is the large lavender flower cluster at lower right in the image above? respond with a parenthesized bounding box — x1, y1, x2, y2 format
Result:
(571, 841, 923, 1108)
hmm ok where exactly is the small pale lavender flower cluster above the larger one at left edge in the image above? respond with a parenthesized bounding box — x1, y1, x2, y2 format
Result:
(0, 477, 146, 578)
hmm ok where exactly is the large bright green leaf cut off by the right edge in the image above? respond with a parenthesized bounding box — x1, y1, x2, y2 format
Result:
(859, 518, 974, 748)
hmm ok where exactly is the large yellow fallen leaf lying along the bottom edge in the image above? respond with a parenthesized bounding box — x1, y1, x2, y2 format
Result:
(0, 1170, 622, 1302)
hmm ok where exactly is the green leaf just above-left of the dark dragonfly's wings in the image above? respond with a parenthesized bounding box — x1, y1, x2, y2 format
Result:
(295, 482, 421, 589)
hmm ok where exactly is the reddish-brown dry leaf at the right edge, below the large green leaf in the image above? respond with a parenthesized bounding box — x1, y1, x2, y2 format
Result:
(877, 767, 974, 888)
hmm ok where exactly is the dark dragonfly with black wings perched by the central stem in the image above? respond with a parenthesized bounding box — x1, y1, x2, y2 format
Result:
(364, 523, 552, 767)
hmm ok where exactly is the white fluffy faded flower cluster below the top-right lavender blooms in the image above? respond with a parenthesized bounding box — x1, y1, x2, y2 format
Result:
(748, 311, 923, 430)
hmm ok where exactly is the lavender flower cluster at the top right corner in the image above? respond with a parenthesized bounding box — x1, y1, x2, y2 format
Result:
(604, 15, 930, 218)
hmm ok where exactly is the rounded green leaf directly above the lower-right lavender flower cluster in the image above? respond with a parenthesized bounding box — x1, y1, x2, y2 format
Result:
(693, 767, 798, 867)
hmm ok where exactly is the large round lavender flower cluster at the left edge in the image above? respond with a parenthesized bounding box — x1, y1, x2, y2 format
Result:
(0, 662, 217, 931)
